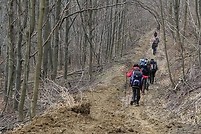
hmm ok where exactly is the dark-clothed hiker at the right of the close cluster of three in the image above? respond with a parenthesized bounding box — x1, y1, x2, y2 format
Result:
(150, 59, 158, 84)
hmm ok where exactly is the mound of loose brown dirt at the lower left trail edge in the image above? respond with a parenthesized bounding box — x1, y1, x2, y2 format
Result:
(8, 103, 93, 134)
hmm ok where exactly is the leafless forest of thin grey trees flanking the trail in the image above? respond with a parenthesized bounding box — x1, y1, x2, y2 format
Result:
(0, 0, 201, 132)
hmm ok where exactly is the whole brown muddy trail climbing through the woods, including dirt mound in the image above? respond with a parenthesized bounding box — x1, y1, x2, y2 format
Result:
(6, 32, 201, 134)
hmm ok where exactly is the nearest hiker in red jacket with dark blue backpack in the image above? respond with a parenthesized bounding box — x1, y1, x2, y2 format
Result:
(127, 64, 142, 106)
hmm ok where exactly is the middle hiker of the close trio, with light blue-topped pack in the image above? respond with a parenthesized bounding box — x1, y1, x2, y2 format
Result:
(140, 59, 150, 94)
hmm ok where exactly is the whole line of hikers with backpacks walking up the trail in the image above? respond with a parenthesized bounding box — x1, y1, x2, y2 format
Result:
(126, 32, 159, 106)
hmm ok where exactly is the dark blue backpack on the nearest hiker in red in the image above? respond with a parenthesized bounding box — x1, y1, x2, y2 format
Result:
(130, 70, 142, 87)
